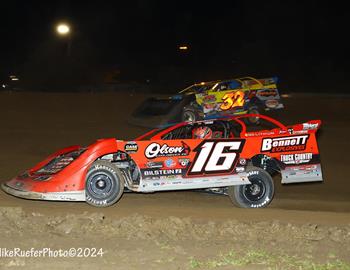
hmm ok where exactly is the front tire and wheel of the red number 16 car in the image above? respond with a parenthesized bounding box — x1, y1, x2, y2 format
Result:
(85, 160, 124, 207)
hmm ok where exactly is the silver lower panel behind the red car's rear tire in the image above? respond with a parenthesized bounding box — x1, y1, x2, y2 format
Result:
(281, 164, 323, 184)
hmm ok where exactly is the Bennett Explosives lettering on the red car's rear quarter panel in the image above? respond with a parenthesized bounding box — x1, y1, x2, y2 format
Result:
(261, 135, 309, 153)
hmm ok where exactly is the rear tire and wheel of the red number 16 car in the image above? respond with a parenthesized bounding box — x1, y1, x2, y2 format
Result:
(228, 167, 275, 208)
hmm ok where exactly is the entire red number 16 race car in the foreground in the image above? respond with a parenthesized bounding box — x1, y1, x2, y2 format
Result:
(2, 115, 322, 208)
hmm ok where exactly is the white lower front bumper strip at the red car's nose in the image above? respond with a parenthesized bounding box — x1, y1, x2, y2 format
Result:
(1, 183, 85, 202)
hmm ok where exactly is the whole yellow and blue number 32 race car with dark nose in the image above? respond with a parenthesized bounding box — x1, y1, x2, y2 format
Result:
(130, 77, 283, 127)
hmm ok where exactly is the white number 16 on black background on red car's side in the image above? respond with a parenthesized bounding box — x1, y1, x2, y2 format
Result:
(187, 140, 245, 175)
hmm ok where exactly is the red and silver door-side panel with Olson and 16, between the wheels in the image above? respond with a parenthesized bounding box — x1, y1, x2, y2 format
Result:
(124, 139, 249, 192)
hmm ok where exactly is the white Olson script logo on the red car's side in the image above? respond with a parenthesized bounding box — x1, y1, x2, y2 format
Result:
(145, 142, 191, 159)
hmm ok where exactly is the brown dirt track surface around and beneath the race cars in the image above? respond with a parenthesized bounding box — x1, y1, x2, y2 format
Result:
(0, 93, 350, 269)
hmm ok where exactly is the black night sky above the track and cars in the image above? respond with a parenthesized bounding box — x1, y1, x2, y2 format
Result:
(0, 0, 350, 93)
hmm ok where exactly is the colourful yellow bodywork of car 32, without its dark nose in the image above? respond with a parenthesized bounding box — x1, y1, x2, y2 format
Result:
(180, 77, 283, 121)
